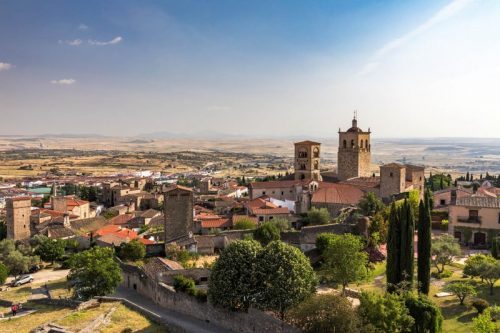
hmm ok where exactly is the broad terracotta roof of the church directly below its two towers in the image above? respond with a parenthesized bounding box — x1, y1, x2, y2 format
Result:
(311, 184, 363, 205)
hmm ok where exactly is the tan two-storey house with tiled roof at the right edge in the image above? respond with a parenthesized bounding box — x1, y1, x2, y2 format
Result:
(448, 196, 500, 245)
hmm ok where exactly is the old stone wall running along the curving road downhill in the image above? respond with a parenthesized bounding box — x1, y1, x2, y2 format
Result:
(123, 267, 300, 333)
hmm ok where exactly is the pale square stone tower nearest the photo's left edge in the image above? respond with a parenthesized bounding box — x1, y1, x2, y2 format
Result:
(6, 197, 31, 240)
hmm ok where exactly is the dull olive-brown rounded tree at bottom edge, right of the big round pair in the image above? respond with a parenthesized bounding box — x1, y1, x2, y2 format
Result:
(286, 294, 360, 333)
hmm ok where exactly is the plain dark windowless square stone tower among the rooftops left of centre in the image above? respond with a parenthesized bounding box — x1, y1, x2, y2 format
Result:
(163, 185, 194, 244)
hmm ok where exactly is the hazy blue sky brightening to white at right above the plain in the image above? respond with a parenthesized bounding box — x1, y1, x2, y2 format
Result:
(0, 0, 500, 138)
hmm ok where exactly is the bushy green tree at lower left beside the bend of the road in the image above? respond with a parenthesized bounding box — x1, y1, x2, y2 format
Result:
(68, 247, 123, 299)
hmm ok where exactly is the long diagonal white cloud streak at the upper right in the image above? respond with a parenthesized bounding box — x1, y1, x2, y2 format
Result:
(359, 0, 475, 76)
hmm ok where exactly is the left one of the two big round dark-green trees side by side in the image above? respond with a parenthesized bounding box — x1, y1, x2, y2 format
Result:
(208, 240, 262, 311)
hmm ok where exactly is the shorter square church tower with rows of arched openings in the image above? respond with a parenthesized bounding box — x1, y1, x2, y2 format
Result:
(295, 141, 322, 181)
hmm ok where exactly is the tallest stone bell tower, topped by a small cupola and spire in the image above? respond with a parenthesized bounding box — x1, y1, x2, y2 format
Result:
(337, 116, 371, 180)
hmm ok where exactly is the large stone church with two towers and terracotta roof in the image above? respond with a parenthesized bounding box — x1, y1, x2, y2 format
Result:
(249, 115, 425, 216)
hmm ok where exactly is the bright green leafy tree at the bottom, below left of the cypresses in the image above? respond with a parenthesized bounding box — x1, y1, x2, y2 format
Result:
(358, 292, 415, 333)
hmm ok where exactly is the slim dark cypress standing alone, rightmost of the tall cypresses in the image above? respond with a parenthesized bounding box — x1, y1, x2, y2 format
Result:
(417, 192, 431, 295)
